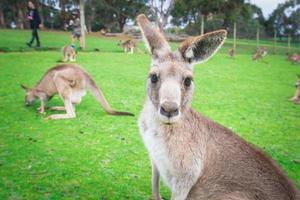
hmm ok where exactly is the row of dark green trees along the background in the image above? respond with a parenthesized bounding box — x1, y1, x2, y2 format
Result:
(0, 0, 300, 39)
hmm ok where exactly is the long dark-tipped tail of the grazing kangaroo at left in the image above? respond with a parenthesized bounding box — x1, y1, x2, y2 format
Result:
(87, 75, 134, 116)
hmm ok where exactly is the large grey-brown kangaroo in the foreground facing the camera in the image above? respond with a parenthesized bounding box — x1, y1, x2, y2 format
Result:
(137, 15, 300, 200)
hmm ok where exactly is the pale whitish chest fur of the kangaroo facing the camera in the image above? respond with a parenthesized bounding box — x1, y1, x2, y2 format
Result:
(139, 102, 203, 194)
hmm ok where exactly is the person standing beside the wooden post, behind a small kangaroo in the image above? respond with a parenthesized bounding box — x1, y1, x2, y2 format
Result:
(69, 9, 82, 49)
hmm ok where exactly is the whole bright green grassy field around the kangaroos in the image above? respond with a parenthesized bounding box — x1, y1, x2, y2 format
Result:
(0, 30, 300, 200)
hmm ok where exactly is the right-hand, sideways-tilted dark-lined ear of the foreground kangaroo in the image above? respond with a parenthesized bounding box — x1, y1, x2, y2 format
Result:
(178, 30, 227, 63)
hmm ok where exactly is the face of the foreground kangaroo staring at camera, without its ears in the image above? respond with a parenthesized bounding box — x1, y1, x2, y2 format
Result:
(147, 56, 194, 124)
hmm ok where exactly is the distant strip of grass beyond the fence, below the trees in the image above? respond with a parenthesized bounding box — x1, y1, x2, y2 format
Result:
(0, 29, 300, 55)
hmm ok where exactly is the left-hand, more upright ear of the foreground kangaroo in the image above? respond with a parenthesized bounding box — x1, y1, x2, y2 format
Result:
(136, 14, 171, 57)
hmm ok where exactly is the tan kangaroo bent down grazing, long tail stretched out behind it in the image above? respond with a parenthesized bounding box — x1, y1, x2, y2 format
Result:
(21, 64, 133, 119)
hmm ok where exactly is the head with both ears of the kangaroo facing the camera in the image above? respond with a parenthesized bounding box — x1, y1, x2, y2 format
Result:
(137, 15, 227, 124)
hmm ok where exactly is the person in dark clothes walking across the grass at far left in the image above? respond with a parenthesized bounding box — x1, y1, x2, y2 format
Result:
(26, 1, 41, 47)
